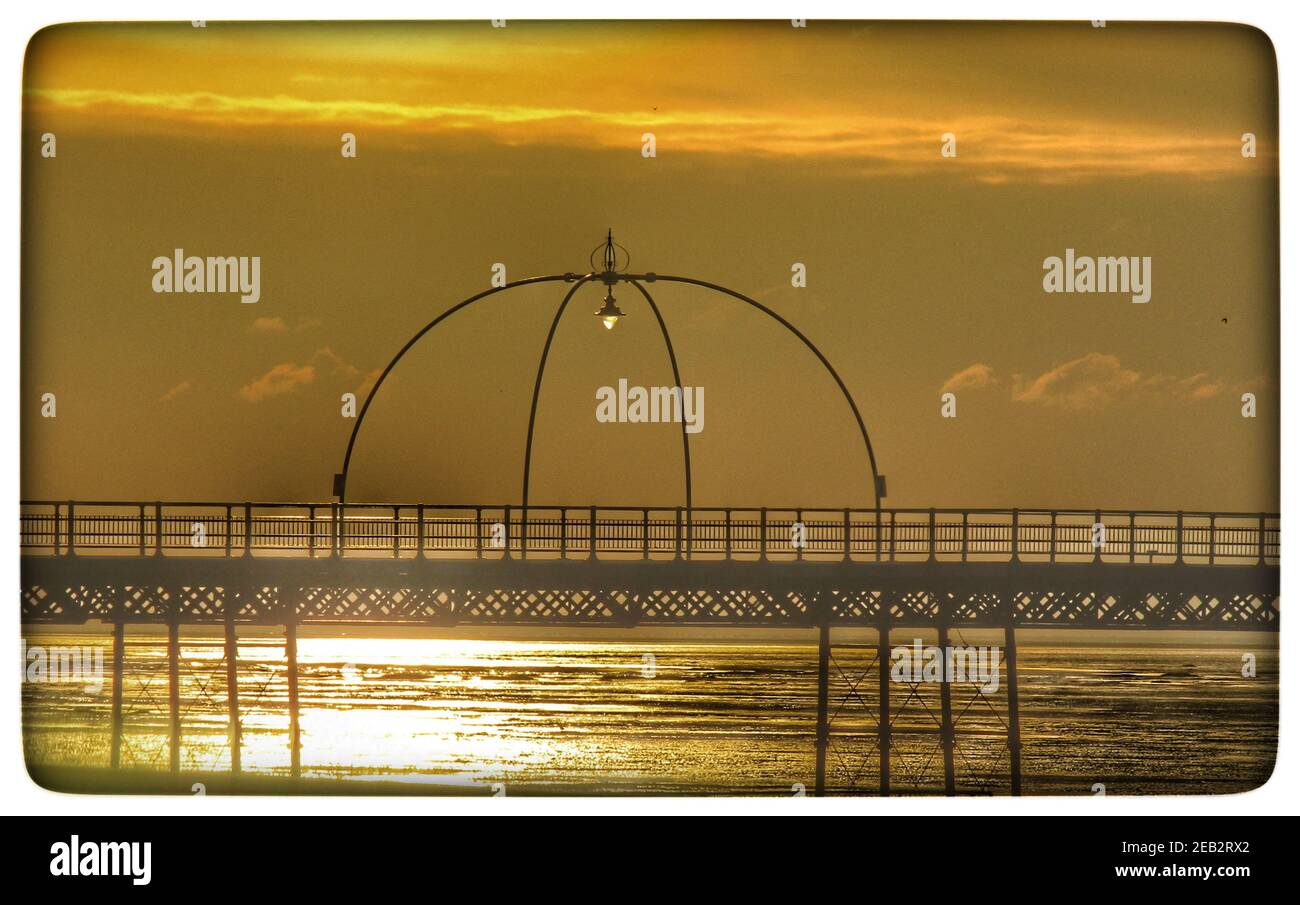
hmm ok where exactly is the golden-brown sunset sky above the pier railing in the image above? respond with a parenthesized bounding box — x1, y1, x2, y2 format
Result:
(21, 21, 1279, 511)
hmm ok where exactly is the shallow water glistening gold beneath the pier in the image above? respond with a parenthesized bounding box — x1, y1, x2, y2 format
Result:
(23, 633, 1278, 794)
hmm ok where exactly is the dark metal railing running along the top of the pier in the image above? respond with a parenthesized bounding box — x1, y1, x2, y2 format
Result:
(20, 501, 1281, 566)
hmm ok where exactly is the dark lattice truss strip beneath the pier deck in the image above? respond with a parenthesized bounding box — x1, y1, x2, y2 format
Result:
(21, 585, 1281, 629)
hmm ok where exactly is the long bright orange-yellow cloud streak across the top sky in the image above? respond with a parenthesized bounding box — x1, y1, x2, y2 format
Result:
(27, 87, 1258, 185)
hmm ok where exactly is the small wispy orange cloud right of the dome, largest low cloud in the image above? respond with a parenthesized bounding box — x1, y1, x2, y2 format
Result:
(1011, 352, 1225, 411)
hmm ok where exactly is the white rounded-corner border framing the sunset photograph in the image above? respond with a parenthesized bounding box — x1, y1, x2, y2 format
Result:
(0, 0, 1300, 817)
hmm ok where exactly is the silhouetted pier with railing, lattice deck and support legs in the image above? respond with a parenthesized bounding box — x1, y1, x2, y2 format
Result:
(21, 501, 1279, 794)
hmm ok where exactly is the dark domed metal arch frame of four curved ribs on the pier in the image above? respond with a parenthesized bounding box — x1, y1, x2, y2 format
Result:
(334, 254, 883, 518)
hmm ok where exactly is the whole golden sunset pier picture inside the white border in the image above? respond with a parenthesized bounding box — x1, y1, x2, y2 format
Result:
(18, 19, 1290, 798)
